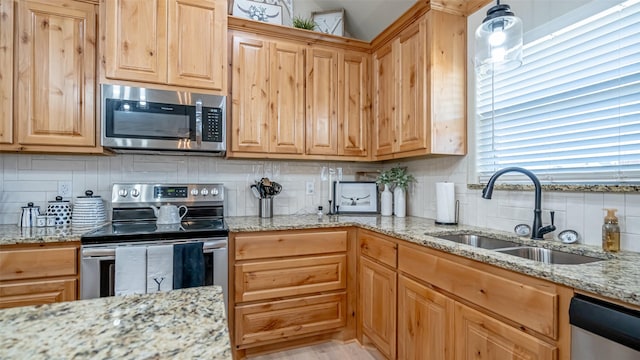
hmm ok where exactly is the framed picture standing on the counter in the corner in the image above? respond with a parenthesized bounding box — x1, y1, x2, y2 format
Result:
(333, 181, 378, 214)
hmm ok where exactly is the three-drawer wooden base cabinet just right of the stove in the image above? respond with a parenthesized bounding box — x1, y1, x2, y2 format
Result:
(229, 229, 355, 358)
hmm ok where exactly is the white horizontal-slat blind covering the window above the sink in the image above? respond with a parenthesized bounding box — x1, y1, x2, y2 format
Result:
(476, 0, 640, 184)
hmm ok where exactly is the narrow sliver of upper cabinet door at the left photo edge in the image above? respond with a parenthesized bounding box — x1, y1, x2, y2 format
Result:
(0, 0, 14, 144)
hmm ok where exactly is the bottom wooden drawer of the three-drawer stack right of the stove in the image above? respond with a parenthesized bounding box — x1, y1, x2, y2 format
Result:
(235, 293, 346, 348)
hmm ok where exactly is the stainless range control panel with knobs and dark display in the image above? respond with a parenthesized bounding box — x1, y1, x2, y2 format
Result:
(111, 184, 224, 205)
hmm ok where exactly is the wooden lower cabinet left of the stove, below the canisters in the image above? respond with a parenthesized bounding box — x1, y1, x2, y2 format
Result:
(0, 244, 79, 308)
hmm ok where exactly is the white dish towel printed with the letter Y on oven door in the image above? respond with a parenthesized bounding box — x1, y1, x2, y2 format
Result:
(147, 245, 173, 294)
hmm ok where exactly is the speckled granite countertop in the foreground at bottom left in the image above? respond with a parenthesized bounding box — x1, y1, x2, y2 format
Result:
(0, 286, 231, 360)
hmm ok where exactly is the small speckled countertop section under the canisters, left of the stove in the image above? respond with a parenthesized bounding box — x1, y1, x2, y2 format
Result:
(0, 225, 88, 245)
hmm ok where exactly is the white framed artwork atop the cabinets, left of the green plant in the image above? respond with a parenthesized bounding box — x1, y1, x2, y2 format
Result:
(230, 0, 293, 25)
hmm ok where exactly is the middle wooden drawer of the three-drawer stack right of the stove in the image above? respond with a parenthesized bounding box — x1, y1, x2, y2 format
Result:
(235, 255, 347, 302)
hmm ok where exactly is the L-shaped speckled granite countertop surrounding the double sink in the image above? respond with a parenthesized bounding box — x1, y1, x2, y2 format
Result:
(225, 215, 640, 305)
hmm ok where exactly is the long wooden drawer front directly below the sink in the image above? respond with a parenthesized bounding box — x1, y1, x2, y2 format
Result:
(398, 246, 558, 339)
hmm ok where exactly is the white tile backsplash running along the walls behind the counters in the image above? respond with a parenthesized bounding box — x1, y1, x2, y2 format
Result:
(0, 154, 640, 252)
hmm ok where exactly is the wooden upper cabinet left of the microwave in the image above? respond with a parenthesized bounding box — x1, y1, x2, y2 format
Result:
(0, 0, 102, 153)
